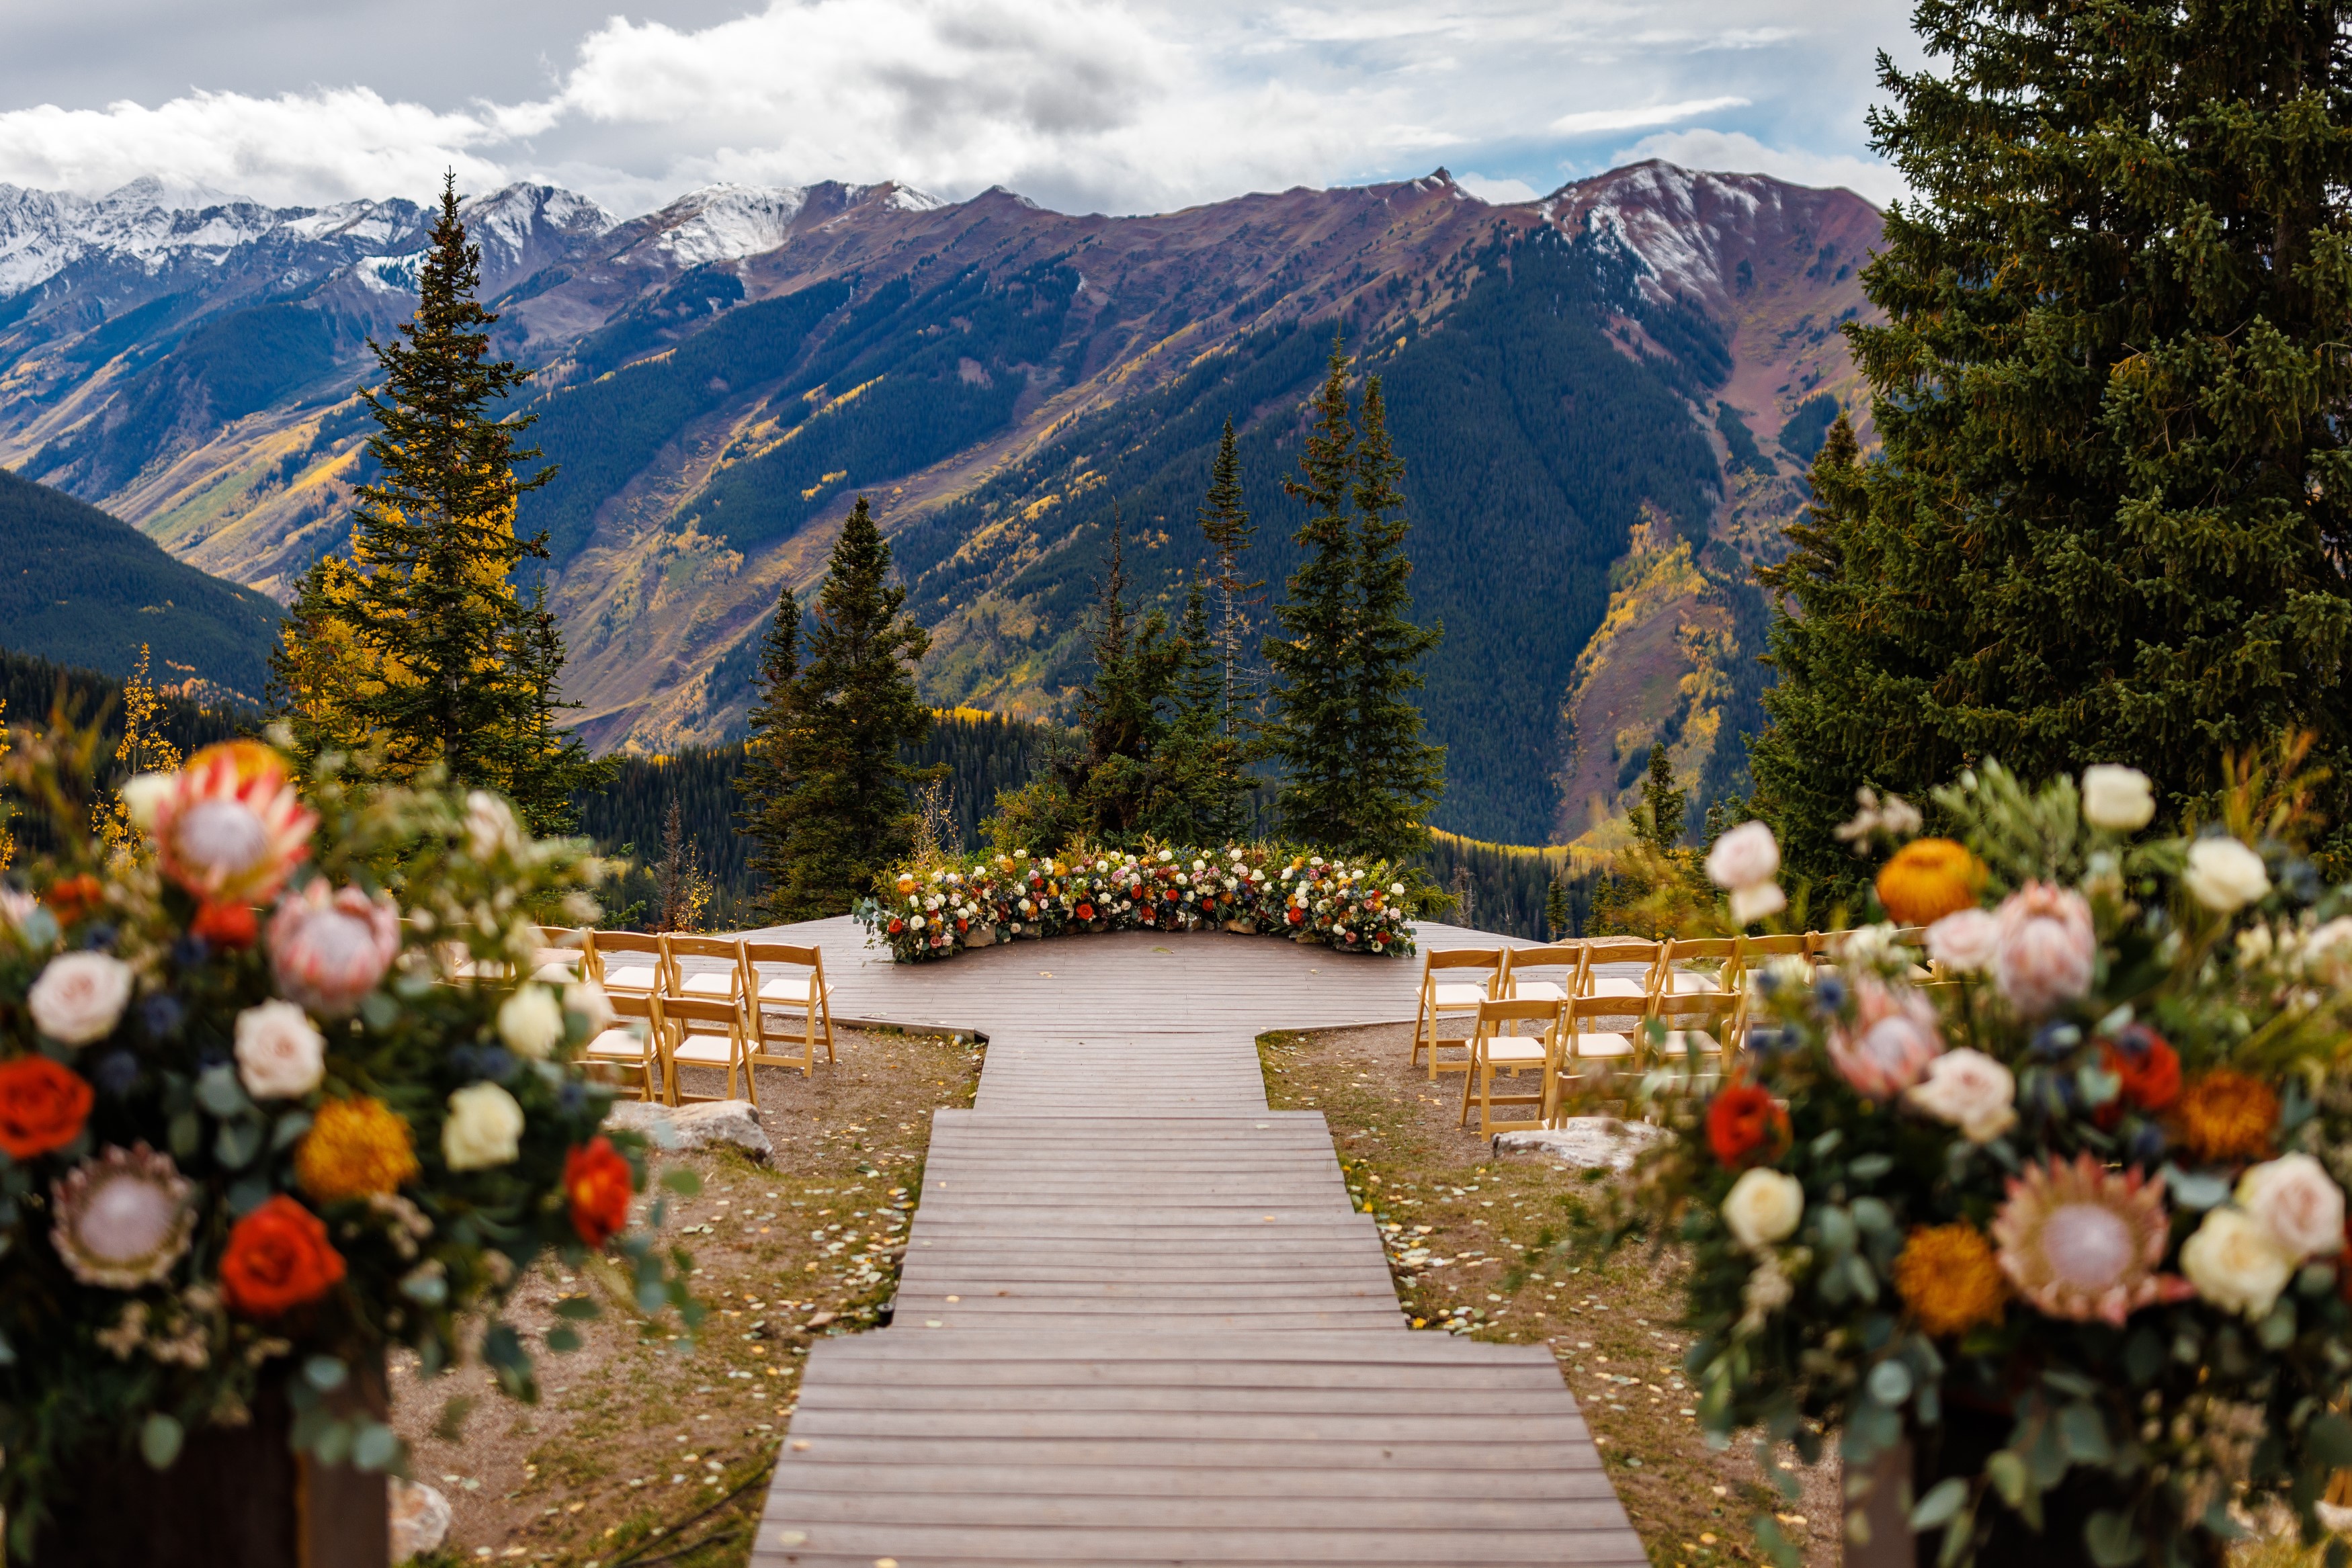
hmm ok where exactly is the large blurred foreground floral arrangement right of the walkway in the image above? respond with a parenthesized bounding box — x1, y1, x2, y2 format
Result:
(1628, 754, 2352, 1566)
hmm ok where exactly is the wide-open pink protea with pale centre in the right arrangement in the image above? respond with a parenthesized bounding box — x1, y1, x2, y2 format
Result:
(1992, 1154, 2190, 1326)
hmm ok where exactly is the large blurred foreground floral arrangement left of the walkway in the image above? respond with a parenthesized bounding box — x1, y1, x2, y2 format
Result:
(0, 734, 701, 1554)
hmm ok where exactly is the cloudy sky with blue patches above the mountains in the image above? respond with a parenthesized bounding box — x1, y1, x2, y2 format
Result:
(0, 0, 1917, 214)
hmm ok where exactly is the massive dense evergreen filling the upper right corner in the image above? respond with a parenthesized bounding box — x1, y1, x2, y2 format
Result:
(1757, 0, 2352, 870)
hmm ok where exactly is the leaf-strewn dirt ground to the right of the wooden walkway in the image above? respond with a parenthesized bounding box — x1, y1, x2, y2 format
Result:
(1259, 1025, 1839, 1568)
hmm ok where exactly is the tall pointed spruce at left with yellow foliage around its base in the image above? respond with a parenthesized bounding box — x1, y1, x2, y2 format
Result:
(271, 176, 597, 832)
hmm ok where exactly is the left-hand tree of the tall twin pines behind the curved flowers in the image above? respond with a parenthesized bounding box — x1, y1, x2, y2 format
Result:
(1265, 334, 1359, 848)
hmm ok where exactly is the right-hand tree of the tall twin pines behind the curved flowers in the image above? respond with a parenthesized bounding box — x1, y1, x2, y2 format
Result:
(1348, 376, 1447, 861)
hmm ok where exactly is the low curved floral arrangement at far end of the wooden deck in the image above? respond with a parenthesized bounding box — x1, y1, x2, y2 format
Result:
(854, 844, 1414, 964)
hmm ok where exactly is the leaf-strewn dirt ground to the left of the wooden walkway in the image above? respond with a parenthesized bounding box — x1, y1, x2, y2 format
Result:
(390, 1030, 981, 1568)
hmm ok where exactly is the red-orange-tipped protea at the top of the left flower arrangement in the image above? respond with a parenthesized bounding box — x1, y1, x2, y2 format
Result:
(155, 740, 318, 903)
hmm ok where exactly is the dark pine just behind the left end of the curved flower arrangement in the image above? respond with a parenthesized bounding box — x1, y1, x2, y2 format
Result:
(769, 496, 931, 919)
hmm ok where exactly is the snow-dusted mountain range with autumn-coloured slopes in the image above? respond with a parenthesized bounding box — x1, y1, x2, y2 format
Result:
(0, 162, 1880, 842)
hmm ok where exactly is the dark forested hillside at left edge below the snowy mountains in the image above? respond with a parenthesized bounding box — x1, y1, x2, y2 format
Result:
(0, 468, 282, 715)
